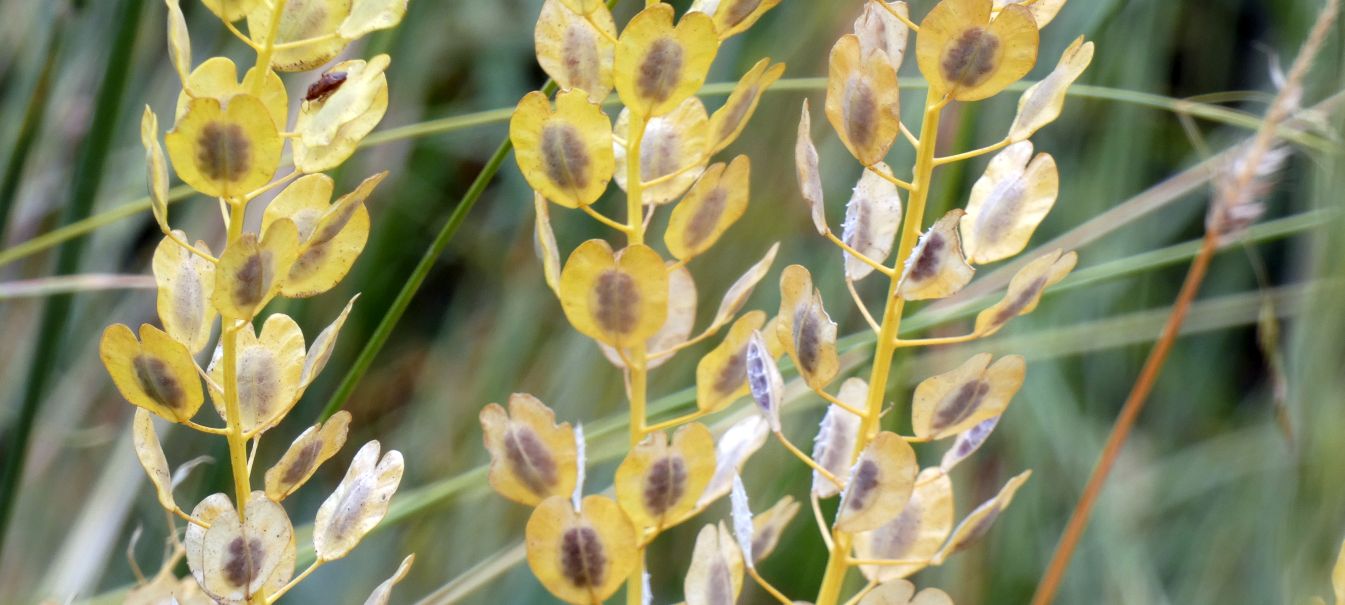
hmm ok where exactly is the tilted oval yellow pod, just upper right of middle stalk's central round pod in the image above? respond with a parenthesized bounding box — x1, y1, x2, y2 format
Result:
(663, 156, 752, 261)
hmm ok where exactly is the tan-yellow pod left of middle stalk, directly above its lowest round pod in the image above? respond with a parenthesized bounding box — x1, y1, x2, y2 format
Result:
(480, 393, 578, 507)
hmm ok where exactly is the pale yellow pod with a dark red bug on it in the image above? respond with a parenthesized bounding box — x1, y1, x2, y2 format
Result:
(292, 55, 391, 173)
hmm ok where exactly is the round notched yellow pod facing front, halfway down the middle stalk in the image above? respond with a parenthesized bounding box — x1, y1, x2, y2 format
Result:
(561, 239, 668, 348)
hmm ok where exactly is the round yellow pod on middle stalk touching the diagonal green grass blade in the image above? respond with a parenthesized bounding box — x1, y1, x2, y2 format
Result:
(508, 90, 616, 208)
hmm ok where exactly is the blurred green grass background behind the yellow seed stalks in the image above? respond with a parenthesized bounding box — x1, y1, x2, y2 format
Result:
(0, 0, 1345, 604)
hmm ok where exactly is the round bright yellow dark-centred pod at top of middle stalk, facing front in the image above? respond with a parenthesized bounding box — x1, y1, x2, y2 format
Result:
(613, 3, 720, 117)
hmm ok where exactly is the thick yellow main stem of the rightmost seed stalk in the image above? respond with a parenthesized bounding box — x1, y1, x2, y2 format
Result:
(814, 90, 947, 605)
